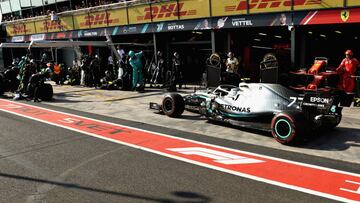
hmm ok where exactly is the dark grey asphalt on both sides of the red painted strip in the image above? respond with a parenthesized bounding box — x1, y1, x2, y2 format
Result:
(0, 99, 360, 202)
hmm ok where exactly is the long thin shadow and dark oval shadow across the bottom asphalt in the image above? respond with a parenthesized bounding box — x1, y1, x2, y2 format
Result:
(0, 172, 211, 203)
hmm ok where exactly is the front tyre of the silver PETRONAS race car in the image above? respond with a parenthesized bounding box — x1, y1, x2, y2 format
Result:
(162, 94, 185, 118)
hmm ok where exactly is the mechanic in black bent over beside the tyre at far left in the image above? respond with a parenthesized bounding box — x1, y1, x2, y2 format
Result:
(26, 68, 52, 102)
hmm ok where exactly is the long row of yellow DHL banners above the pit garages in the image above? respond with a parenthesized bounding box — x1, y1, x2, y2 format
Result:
(6, 0, 352, 36)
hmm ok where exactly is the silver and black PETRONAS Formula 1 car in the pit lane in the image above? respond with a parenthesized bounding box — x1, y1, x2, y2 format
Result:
(150, 83, 352, 145)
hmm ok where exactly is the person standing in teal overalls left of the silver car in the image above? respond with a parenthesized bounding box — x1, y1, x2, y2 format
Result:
(129, 51, 145, 91)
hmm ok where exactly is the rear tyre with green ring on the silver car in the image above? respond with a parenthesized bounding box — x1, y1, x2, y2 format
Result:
(271, 113, 306, 145)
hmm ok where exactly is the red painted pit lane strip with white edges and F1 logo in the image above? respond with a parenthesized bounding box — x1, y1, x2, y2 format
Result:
(0, 99, 360, 202)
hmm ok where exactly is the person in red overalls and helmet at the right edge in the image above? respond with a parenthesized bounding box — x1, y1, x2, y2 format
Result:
(336, 50, 360, 93)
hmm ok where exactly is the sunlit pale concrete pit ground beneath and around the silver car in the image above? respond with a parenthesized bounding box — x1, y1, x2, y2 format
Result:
(39, 85, 360, 163)
